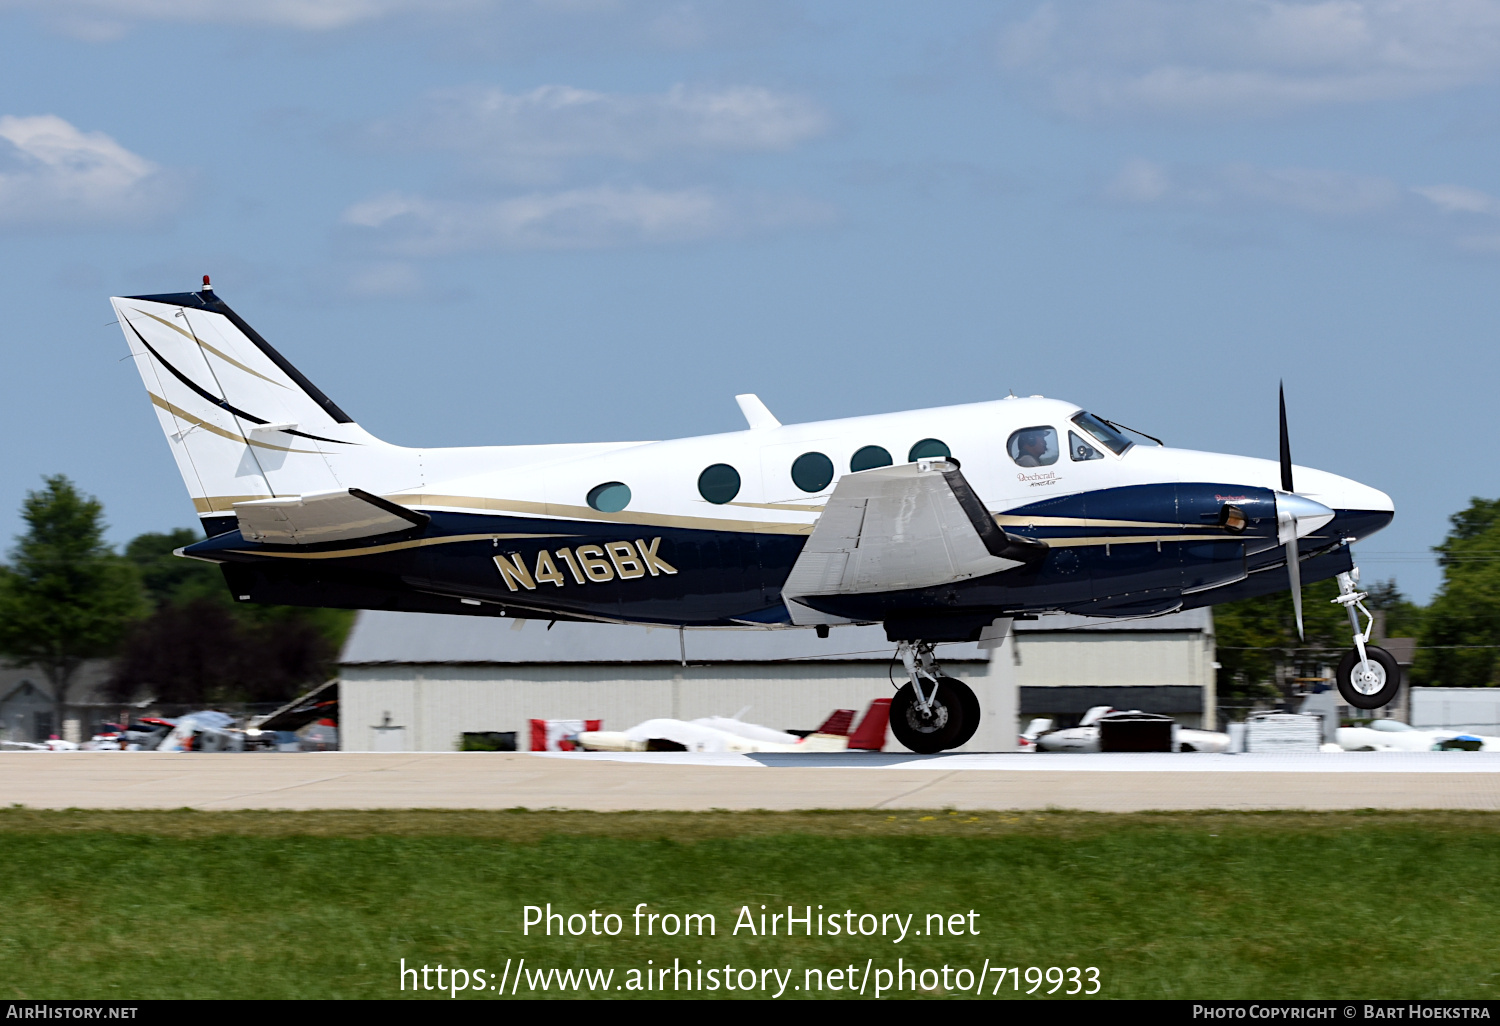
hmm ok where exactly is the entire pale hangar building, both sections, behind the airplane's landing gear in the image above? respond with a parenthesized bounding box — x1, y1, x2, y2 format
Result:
(339, 611, 1214, 752)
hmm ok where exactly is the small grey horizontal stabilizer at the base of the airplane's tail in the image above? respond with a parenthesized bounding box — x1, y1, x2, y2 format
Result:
(234, 488, 431, 545)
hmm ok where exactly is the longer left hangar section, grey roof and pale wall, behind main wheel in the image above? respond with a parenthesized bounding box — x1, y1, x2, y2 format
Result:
(339, 612, 1017, 752)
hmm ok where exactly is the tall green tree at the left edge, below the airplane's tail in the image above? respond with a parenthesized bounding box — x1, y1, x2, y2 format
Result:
(0, 474, 146, 726)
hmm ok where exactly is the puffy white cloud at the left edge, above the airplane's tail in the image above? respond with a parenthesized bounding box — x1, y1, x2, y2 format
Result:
(0, 114, 176, 228)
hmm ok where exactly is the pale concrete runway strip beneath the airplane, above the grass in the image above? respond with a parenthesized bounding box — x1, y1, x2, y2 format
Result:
(0, 752, 1500, 812)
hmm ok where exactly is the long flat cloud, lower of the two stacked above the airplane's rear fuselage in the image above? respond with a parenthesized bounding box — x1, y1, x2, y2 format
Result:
(344, 186, 830, 257)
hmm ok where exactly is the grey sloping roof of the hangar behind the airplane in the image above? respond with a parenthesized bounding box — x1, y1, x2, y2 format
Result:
(339, 609, 1211, 666)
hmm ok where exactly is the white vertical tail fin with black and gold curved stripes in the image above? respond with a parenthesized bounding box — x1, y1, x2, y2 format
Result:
(111, 278, 389, 534)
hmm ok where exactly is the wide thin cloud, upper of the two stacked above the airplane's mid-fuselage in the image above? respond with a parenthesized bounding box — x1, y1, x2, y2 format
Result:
(371, 86, 828, 177)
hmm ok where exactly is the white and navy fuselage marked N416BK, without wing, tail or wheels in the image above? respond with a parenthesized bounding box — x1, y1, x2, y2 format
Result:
(189, 398, 1392, 636)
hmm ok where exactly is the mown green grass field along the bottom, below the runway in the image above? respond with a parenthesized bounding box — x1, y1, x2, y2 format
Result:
(0, 809, 1500, 1001)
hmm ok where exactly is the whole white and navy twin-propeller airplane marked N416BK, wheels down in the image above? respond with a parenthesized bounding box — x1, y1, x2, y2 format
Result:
(113, 276, 1400, 753)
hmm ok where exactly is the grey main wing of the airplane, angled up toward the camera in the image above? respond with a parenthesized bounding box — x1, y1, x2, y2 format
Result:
(782, 459, 1046, 624)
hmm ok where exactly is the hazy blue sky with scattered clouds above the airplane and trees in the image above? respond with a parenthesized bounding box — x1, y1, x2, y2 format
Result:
(0, 0, 1500, 600)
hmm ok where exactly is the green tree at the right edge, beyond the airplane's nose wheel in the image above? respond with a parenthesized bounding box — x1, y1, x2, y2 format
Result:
(1413, 498, 1500, 687)
